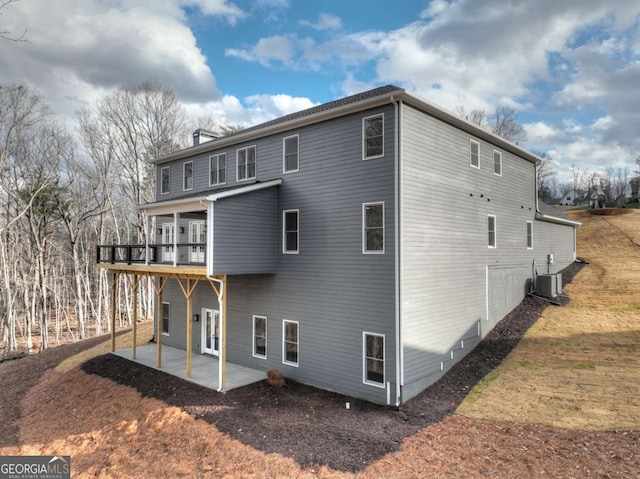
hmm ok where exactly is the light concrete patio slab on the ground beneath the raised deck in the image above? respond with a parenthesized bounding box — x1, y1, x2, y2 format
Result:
(111, 344, 266, 391)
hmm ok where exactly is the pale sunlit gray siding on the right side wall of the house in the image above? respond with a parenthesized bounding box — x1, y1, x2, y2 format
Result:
(401, 105, 535, 400)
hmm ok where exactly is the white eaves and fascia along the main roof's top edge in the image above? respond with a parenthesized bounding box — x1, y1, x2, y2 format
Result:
(149, 85, 541, 164)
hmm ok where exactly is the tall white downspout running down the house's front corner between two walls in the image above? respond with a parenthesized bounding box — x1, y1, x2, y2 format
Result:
(387, 96, 404, 407)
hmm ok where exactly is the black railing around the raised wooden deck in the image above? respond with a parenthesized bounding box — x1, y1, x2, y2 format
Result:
(96, 243, 207, 265)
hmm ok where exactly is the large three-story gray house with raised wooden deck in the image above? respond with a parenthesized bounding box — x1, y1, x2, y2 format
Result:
(98, 86, 579, 405)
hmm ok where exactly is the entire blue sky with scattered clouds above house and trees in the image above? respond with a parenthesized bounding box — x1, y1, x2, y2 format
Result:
(0, 0, 640, 186)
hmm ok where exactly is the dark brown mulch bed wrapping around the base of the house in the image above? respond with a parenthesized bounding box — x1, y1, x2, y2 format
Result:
(77, 263, 604, 472)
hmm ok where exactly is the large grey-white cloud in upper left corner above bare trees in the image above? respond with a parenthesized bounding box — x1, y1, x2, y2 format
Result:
(0, 0, 230, 122)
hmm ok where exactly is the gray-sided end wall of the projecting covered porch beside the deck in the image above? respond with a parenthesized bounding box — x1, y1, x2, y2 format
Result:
(213, 187, 280, 274)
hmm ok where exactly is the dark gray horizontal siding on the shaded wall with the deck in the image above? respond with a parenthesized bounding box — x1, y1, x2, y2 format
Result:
(153, 105, 396, 404)
